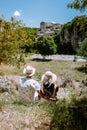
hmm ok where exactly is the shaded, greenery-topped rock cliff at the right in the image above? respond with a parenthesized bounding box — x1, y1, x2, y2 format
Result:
(60, 16, 87, 51)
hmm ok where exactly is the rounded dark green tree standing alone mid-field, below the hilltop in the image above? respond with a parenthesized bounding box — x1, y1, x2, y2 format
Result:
(34, 36, 57, 58)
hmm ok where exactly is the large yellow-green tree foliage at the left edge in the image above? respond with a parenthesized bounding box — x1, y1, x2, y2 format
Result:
(0, 17, 37, 64)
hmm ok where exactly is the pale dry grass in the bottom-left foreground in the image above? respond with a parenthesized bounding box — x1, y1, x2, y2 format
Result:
(0, 104, 51, 130)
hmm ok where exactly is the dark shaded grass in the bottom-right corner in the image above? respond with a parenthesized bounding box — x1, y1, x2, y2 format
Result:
(50, 99, 87, 130)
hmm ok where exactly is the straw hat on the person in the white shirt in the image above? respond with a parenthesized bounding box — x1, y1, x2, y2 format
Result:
(23, 65, 35, 76)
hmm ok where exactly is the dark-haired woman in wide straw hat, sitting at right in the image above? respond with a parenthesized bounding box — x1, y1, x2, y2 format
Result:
(41, 71, 59, 98)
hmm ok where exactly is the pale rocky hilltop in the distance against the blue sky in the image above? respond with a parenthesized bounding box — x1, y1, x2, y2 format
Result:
(37, 21, 62, 36)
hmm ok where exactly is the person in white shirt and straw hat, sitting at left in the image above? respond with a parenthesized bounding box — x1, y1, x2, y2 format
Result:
(18, 65, 40, 103)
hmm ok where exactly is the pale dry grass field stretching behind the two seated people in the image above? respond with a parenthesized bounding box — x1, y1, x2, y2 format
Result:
(0, 59, 87, 81)
